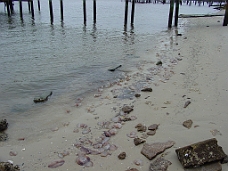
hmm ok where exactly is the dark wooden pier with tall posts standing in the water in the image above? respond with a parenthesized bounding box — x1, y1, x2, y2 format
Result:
(0, 0, 228, 28)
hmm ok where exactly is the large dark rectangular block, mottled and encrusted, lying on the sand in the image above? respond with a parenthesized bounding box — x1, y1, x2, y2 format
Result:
(176, 138, 226, 168)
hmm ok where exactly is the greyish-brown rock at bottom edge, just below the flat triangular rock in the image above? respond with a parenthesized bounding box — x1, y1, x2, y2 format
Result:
(149, 157, 172, 171)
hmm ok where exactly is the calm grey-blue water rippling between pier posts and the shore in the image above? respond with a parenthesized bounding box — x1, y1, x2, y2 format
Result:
(0, 0, 214, 136)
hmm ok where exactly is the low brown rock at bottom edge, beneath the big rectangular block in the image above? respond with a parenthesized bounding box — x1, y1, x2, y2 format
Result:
(184, 162, 222, 171)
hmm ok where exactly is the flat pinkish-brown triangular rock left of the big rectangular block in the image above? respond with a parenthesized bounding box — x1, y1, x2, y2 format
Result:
(141, 141, 175, 160)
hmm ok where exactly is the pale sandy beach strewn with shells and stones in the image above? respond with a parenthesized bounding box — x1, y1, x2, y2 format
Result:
(0, 11, 228, 171)
